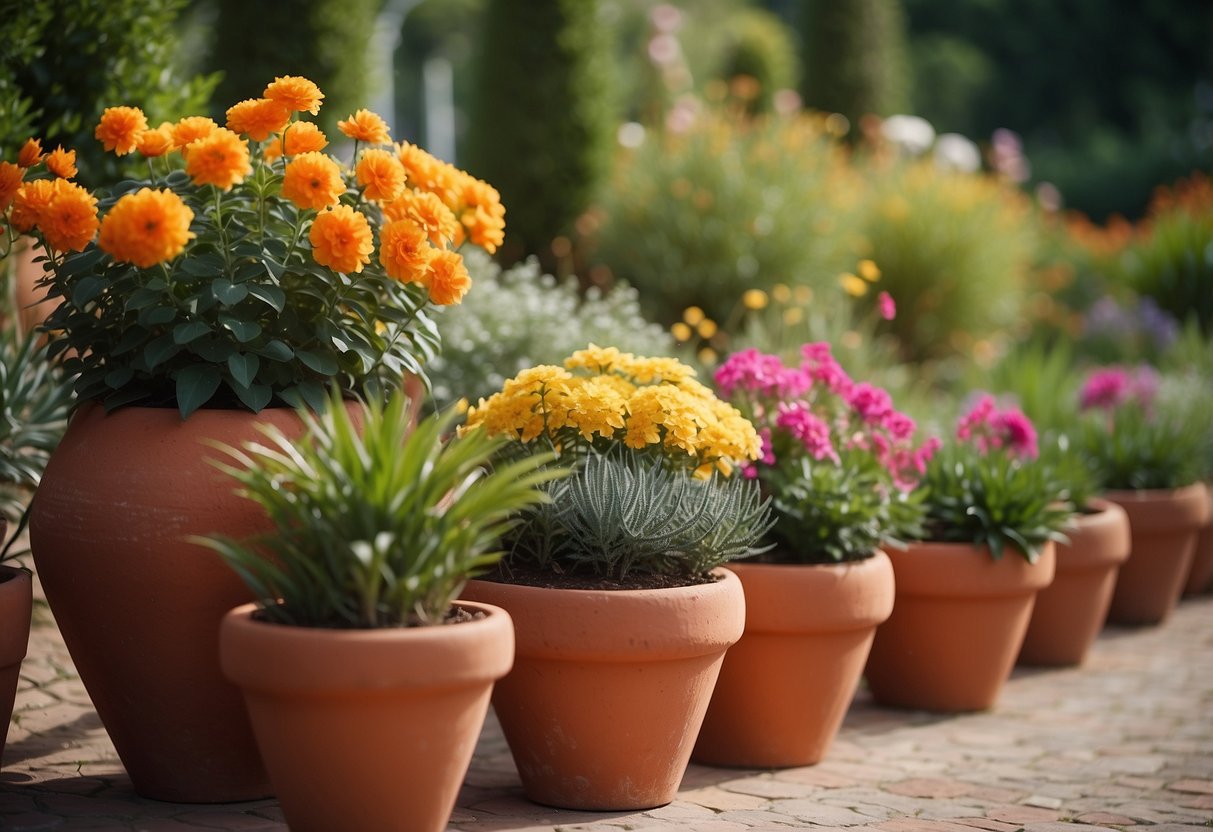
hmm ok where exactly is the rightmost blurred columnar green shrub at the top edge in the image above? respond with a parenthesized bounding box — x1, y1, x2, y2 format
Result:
(801, 0, 909, 127)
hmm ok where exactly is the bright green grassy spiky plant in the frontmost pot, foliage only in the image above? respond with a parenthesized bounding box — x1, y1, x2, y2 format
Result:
(198, 392, 564, 628)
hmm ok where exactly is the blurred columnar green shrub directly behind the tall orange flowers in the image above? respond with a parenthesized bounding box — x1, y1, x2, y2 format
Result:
(205, 0, 387, 133)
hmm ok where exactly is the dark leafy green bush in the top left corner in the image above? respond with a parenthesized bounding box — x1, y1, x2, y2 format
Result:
(0, 0, 215, 188)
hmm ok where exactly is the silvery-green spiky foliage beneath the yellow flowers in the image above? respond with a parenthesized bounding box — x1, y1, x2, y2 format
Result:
(509, 450, 773, 580)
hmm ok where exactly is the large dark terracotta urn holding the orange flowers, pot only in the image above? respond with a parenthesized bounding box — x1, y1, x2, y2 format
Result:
(29, 404, 329, 803)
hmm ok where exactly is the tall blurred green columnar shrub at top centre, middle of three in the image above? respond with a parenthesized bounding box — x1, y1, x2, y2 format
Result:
(467, 0, 614, 264)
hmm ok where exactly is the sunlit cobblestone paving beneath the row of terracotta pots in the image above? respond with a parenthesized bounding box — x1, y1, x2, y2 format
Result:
(0, 579, 1213, 832)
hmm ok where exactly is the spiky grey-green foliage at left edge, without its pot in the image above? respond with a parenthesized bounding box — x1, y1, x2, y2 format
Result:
(0, 326, 73, 559)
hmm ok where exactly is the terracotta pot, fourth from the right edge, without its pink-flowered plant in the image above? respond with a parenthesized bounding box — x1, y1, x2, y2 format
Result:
(865, 542, 1055, 713)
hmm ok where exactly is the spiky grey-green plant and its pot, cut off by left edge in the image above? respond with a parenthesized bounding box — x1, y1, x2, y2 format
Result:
(0, 326, 72, 762)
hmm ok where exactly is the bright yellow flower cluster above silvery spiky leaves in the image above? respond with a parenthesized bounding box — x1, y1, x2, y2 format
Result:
(463, 344, 762, 474)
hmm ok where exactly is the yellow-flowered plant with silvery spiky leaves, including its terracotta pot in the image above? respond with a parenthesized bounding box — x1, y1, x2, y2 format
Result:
(463, 344, 769, 810)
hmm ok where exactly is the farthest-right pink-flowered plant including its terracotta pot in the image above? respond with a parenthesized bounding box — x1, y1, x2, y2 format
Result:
(1080, 366, 1209, 625)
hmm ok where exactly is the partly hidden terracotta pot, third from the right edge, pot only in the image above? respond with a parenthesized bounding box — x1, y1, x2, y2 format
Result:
(1019, 500, 1129, 667)
